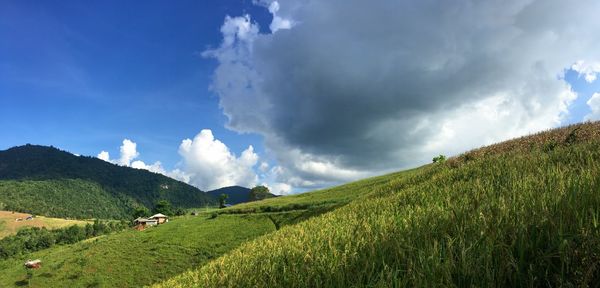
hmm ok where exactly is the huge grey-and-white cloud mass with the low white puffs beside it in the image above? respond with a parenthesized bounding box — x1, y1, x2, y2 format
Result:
(98, 0, 600, 193)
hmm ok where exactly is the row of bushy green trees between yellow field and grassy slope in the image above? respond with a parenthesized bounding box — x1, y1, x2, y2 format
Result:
(0, 220, 129, 259)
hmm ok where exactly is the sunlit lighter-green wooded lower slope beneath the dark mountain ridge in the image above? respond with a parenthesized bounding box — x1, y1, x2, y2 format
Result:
(0, 179, 131, 219)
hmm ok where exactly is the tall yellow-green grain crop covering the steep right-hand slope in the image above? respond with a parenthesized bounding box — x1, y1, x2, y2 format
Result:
(157, 123, 600, 287)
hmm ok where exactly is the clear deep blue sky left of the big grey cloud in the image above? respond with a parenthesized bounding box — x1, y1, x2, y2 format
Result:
(0, 0, 271, 167)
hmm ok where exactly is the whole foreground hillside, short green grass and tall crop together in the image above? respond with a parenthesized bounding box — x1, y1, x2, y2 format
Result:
(0, 123, 600, 287)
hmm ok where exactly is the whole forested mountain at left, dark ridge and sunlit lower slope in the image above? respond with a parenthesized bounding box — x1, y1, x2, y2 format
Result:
(0, 144, 216, 219)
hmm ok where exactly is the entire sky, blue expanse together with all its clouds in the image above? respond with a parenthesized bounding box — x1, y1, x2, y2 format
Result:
(0, 0, 600, 193)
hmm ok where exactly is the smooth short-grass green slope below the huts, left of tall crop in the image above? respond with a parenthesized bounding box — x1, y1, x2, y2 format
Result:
(0, 214, 275, 287)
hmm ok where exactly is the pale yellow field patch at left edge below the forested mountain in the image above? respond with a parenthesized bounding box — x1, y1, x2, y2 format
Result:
(0, 211, 90, 239)
